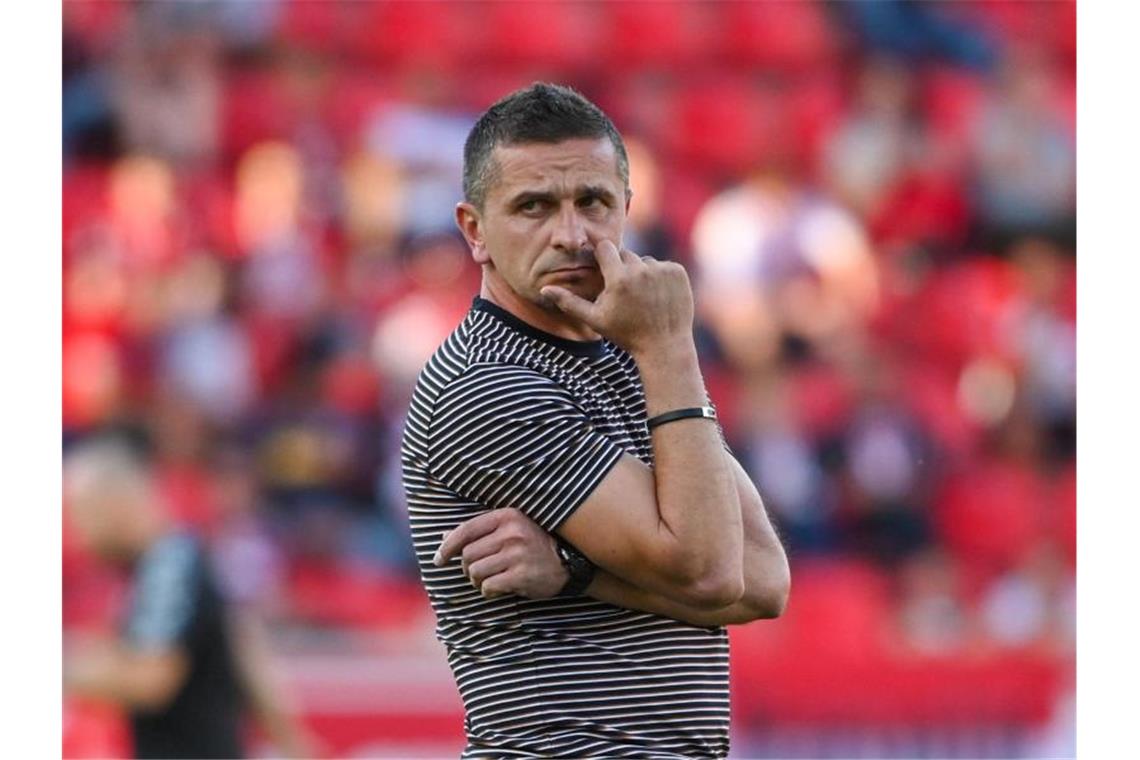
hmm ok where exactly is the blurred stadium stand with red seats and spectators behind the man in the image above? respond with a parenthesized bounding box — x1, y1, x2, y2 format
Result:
(63, 0, 1076, 758)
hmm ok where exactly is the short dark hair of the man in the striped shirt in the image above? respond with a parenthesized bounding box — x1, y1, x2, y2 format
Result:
(463, 82, 629, 209)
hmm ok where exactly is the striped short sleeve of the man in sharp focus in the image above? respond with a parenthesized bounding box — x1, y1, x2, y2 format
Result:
(429, 365, 624, 531)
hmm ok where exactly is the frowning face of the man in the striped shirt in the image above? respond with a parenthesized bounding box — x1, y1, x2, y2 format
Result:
(459, 137, 628, 310)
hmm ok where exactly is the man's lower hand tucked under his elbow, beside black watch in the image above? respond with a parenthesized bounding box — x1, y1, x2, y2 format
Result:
(434, 508, 569, 599)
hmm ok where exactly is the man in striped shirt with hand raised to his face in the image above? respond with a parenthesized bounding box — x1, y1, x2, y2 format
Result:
(402, 84, 789, 758)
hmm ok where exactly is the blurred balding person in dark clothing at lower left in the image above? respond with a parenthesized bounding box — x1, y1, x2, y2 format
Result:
(64, 439, 312, 758)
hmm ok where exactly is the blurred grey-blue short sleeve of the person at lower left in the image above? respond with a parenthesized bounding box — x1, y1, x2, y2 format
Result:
(127, 536, 197, 649)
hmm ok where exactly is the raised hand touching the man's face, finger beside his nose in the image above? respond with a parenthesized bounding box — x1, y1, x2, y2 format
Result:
(542, 240, 693, 357)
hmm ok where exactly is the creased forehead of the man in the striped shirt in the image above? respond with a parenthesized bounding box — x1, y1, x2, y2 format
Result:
(491, 137, 621, 183)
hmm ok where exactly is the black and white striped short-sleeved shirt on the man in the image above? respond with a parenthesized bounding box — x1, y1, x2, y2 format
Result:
(402, 299, 728, 758)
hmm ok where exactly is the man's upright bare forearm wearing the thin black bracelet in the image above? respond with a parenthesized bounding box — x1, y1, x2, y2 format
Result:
(635, 337, 743, 596)
